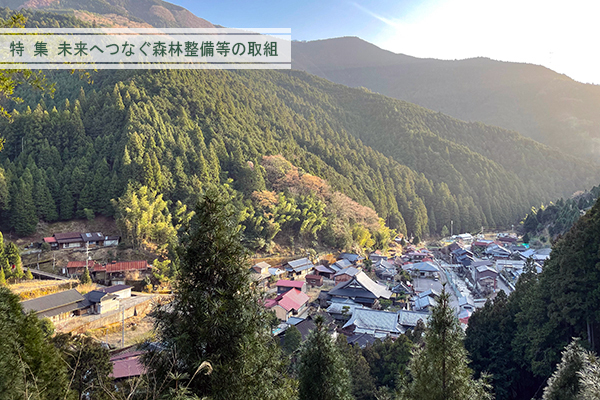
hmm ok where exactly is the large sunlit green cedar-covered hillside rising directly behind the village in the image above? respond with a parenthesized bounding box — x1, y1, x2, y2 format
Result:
(0, 67, 598, 247)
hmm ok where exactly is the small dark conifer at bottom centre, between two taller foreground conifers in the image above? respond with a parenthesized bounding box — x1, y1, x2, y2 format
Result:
(298, 316, 352, 400)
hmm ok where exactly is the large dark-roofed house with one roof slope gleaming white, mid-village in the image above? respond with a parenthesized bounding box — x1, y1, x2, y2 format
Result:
(328, 271, 392, 308)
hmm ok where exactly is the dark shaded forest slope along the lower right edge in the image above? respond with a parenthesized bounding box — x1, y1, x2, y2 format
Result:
(465, 195, 600, 400)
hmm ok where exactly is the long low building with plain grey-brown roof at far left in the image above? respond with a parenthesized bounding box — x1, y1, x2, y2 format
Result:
(21, 289, 90, 323)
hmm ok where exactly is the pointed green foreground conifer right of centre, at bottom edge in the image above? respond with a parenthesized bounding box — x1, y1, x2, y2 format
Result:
(401, 288, 493, 400)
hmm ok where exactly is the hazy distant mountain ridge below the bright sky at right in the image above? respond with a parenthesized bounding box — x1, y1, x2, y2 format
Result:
(292, 37, 600, 160)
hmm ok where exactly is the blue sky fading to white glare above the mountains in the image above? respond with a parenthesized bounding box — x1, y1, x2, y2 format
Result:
(176, 0, 600, 84)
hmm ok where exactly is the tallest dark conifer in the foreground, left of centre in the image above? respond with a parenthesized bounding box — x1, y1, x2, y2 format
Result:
(144, 190, 295, 400)
